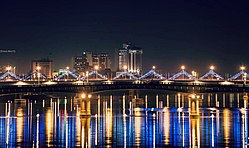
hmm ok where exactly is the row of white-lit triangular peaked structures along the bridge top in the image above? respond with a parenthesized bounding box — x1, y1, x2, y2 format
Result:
(0, 66, 248, 82)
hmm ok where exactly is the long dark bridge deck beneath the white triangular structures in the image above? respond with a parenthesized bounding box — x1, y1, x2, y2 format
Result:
(0, 81, 249, 95)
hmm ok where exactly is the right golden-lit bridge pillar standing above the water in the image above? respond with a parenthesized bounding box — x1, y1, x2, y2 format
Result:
(189, 94, 200, 118)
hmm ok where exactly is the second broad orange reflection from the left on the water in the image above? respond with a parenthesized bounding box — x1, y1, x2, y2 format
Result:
(46, 108, 54, 147)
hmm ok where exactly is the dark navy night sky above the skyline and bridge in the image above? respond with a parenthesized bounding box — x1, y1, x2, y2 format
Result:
(0, 0, 249, 74)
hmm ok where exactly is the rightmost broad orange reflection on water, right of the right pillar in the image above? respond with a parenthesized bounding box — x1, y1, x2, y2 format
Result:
(223, 109, 232, 146)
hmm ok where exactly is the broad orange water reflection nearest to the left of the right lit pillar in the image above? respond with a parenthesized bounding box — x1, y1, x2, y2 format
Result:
(163, 108, 170, 145)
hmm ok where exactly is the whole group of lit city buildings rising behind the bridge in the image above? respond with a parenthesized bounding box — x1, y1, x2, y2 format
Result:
(27, 43, 143, 78)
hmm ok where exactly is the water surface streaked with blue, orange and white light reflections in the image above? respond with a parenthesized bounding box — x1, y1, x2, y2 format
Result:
(0, 94, 249, 147)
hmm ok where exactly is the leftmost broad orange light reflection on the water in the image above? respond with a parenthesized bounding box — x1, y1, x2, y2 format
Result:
(16, 108, 24, 142)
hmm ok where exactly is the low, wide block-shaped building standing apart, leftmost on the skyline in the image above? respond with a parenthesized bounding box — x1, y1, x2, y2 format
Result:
(31, 59, 53, 78)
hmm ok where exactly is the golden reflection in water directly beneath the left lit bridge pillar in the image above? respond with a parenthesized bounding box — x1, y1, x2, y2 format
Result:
(80, 116, 91, 148)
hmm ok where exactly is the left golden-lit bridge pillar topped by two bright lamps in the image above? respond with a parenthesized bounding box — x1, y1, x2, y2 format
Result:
(80, 93, 92, 116)
